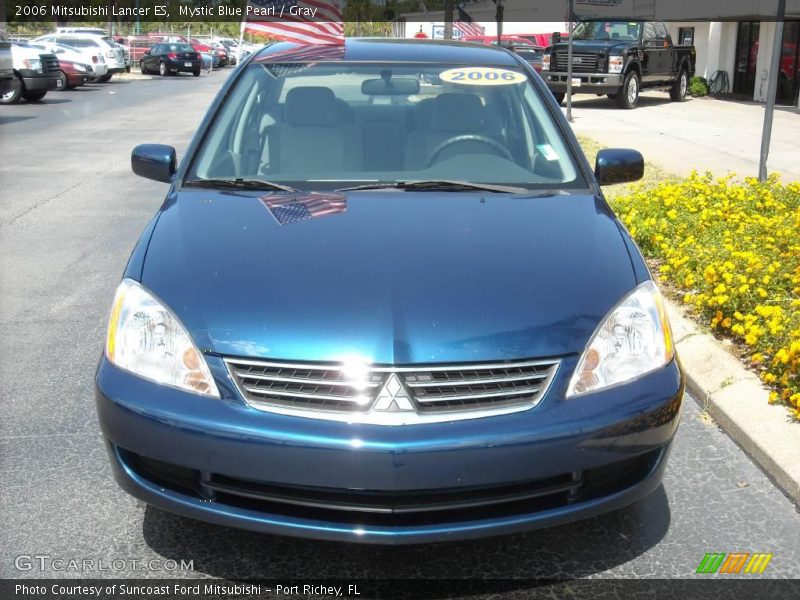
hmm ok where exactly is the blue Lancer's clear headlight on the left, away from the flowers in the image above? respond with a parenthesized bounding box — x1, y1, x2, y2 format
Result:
(106, 279, 220, 398)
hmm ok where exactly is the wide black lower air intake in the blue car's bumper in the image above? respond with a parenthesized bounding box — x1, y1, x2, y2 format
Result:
(118, 448, 663, 526)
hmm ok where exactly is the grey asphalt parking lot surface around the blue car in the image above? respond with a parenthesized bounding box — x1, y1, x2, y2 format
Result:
(0, 69, 800, 579)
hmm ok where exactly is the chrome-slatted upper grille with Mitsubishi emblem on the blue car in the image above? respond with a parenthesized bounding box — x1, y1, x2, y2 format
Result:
(225, 358, 558, 424)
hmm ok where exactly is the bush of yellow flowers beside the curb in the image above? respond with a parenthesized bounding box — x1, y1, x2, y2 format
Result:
(610, 173, 800, 418)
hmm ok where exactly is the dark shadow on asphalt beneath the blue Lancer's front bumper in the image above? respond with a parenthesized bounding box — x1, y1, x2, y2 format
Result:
(142, 486, 670, 591)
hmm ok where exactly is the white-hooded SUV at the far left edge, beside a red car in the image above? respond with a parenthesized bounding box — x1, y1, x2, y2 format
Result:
(0, 42, 61, 104)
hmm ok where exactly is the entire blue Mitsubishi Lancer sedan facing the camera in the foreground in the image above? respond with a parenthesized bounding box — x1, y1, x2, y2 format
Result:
(96, 40, 683, 543)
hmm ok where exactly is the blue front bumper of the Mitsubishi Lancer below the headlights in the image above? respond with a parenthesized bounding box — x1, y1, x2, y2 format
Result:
(96, 357, 683, 544)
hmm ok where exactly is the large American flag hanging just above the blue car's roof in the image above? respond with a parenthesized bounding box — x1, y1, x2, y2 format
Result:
(244, 0, 344, 44)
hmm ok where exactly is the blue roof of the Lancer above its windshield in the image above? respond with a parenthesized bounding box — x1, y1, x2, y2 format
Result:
(253, 38, 518, 67)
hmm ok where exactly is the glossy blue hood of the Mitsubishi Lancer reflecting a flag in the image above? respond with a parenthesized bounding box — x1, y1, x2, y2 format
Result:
(142, 190, 636, 364)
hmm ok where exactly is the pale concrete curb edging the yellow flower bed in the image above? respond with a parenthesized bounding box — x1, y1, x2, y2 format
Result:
(666, 299, 800, 510)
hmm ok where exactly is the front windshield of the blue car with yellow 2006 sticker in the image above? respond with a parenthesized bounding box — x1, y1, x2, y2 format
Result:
(191, 59, 587, 189)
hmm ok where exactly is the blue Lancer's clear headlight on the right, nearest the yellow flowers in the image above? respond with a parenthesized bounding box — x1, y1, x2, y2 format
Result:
(567, 281, 675, 398)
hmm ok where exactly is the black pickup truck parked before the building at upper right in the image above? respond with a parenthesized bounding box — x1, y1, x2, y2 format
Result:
(542, 20, 696, 108)
